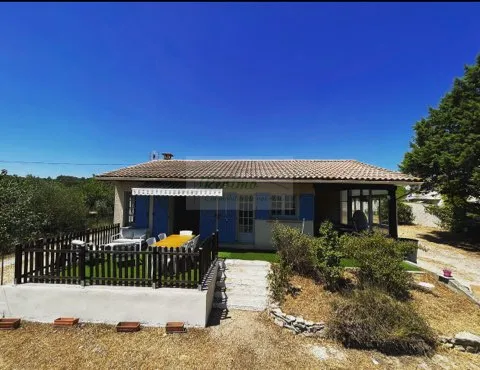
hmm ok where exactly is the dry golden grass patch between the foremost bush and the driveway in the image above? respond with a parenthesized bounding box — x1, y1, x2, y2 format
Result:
(412, 274, 480, 335)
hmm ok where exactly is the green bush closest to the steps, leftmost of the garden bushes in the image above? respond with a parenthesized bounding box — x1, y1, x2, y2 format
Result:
(272, 221, 316, 276)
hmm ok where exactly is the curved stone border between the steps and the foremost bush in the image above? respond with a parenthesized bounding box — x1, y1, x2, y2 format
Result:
(268, 304, 325, 337)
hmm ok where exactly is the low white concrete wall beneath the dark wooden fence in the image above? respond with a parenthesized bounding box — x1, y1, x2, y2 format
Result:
(0, 278, 216, 327)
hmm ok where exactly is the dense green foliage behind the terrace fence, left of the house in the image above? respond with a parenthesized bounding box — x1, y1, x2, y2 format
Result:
(0, 171, 114, 252)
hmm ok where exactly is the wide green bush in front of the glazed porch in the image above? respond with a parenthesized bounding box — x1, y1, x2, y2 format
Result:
(342, 231, 416, 299)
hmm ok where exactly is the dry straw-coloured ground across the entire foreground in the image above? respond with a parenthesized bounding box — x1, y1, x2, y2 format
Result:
(0, 311, 480, 370)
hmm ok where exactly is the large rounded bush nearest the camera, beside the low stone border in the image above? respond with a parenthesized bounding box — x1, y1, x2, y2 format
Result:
(327, 289, 435, 355)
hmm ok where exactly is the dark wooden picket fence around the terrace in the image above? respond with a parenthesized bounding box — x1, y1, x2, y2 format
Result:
(15, 228, 218, 288)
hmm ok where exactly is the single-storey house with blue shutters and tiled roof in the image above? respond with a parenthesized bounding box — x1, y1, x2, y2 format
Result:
(97, 153, 421, 250)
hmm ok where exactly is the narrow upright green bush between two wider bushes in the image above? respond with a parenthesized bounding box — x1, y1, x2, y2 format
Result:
(313, 221, 343, 290)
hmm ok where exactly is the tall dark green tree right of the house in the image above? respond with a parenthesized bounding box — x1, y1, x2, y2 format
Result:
(400, 55, 480, 231)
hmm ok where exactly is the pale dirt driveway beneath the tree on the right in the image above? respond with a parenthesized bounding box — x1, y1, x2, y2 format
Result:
(398, 225, 480, 292)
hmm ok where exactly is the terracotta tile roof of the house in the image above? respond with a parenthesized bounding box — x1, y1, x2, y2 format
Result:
(97, 159, 421, 182)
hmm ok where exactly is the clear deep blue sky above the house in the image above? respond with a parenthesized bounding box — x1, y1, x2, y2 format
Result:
(0, 3, 480, 176)
